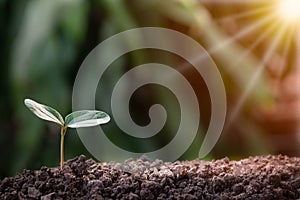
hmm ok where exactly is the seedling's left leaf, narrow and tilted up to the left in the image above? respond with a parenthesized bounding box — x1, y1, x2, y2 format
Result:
(24, 99, 64, 126)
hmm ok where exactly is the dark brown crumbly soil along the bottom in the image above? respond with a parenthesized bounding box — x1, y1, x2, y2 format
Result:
(0, 155, 300, 200)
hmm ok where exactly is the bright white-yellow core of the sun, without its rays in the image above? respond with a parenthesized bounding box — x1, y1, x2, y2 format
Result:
(277, 0, 300, 24)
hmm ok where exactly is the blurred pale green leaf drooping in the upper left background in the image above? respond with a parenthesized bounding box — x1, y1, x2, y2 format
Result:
(12, 0, 85, 81)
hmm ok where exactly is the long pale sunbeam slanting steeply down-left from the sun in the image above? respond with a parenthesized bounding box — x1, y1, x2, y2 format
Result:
(224, 23, 286, 128)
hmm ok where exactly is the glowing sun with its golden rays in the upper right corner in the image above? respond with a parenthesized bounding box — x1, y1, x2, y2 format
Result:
(206, 0, 300, 130)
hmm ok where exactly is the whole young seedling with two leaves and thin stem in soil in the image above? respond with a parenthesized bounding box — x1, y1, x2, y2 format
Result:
(24, 99, 110, 167)
